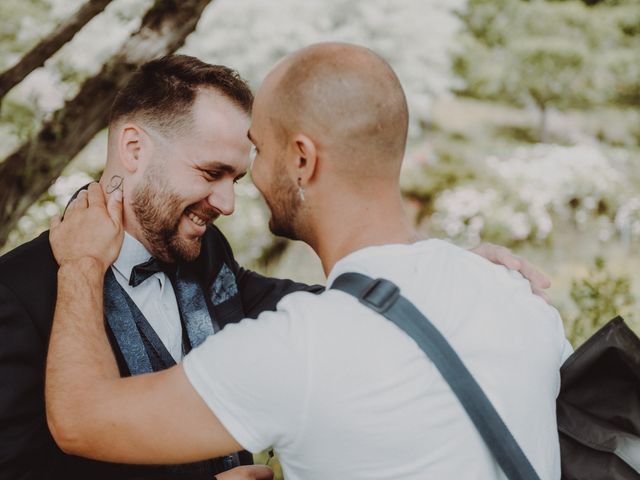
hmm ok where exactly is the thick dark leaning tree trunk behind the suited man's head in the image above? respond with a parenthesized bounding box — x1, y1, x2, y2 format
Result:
(0, 0, 211, 247)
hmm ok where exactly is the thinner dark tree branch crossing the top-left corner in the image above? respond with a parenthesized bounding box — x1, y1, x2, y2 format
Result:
(0, 0, 112, 100)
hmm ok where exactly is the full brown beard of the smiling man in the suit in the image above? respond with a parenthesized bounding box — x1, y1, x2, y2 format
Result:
(131, 167, 211, 263)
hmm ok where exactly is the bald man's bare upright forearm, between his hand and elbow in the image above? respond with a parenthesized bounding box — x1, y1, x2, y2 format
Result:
(45, 257, 119, 449)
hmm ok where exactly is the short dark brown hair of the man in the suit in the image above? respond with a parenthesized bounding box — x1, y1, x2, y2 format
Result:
(109, 55, 253, 133)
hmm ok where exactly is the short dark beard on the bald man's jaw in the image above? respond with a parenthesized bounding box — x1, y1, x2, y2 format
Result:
(264, 167, 302, 240)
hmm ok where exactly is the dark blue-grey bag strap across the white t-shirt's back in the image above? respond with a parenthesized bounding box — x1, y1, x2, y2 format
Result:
(330, 272, 539, 480)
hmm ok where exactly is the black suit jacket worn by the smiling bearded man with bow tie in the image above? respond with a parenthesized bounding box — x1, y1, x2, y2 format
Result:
(0, 227, 322, 480)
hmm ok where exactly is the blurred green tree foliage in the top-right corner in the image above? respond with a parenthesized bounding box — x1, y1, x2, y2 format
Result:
(453, 0, 640, 120)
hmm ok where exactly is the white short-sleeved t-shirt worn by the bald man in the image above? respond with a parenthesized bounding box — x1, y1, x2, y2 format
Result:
(184, 240, 570, 480)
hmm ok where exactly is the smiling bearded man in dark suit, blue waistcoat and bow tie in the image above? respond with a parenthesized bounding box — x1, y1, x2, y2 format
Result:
(0, 55, 308, 480)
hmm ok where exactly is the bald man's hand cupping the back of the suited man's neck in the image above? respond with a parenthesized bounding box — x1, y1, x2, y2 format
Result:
(49, 183, 124, 273)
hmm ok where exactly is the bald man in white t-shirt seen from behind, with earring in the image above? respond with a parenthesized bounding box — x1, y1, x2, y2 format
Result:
(46, 44, 566, 480)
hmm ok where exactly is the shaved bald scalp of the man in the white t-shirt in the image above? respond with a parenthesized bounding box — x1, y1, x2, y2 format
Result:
(260, 43, 408, 176)
